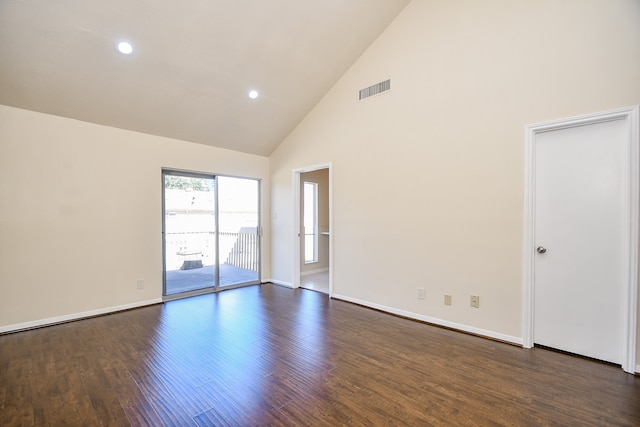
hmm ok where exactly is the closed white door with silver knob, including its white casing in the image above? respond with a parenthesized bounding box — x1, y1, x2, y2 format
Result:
(523, 106, 638, 373)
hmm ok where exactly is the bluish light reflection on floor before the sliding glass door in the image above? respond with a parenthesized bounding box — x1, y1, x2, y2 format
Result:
(148, 286, 272, 407)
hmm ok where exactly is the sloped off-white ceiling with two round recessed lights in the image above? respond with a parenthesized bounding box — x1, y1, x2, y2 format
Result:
(0, 0, 409, 155)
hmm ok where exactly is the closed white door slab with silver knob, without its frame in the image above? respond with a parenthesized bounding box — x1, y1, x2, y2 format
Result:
(533, 120, 628, 364)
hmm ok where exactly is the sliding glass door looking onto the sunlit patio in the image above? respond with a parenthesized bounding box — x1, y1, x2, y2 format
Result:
(162, 170, 260, 296)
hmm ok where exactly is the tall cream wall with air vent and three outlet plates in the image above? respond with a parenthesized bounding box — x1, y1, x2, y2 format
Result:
(271, 0, 640, 342)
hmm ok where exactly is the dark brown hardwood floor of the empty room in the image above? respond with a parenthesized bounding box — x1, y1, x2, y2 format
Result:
(0, 284, 640, 426)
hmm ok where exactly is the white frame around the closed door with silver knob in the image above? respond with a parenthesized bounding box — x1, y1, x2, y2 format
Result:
(522, 105, 640, 374)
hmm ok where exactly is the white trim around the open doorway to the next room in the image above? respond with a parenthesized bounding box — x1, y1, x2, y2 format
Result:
(292, 162, 333, 297)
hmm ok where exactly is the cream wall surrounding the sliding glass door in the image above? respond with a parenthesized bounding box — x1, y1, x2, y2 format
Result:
(0, 106, 269, 331)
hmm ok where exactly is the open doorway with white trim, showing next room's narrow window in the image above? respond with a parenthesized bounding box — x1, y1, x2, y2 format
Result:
(294, 163, 333, 295)
